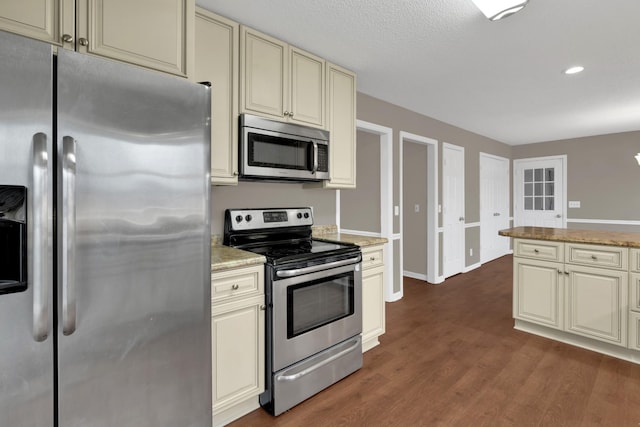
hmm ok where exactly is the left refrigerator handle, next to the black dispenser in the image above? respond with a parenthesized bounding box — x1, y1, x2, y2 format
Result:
(31, 132, 52, 342)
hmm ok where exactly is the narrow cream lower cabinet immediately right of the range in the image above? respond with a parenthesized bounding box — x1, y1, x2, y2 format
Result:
(362, 245, 385, 352)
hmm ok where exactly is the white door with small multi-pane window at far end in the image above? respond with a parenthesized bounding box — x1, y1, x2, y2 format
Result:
(513, 156, 566, 228)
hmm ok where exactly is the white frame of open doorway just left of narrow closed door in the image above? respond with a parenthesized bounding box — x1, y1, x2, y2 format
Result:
(399, 131, 444, 283)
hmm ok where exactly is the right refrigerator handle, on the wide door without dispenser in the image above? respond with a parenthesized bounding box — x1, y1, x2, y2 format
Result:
(62, 136, 76, 335)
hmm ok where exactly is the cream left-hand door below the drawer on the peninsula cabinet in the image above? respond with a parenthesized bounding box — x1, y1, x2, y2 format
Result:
(513, 258, 563, 329)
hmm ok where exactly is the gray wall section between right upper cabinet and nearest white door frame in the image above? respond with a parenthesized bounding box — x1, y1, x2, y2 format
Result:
(340, 131, 381, 233)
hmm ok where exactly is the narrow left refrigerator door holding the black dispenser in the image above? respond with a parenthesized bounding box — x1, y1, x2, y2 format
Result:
(0, 31, 54, 427)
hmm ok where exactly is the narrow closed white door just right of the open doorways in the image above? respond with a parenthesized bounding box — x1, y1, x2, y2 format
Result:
(442, 143, 464, 277)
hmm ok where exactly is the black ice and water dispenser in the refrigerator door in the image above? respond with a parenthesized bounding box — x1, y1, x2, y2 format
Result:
(0, 185, 27, 295)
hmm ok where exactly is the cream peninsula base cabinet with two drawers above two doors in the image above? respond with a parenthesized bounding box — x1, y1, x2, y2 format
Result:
(513, 239, 629, 347)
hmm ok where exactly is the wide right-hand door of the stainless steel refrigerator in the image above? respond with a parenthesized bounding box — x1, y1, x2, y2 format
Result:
(57, 50, 211, 427)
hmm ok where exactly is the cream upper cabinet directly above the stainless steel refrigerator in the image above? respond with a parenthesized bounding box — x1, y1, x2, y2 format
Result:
(0, 0, 195, 76)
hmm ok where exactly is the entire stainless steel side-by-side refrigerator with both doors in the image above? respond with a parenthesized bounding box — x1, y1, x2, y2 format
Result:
(0, 31, 211, 427)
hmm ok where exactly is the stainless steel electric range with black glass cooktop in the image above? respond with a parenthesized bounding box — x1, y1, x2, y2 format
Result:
(224, 208, 362, 415)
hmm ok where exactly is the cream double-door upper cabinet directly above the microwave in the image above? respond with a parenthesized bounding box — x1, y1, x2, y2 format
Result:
(240, 26, 326, 128)
